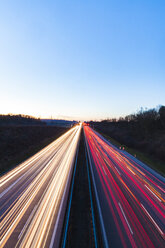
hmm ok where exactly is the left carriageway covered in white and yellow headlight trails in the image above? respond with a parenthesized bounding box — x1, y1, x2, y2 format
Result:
(0, 125, 81, 248)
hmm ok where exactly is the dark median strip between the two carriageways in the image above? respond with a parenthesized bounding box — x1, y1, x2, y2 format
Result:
(65, 129, 95, 248)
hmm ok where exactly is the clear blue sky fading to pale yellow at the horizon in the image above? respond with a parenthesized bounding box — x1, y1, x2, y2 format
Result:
(0, 0, 165, 120)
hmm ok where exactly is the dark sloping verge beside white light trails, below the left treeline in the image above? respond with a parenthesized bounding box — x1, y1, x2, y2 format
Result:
(0, 126, 68, 175)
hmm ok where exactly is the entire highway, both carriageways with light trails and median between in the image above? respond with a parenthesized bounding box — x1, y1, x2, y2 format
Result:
(0, 125, 165, 248)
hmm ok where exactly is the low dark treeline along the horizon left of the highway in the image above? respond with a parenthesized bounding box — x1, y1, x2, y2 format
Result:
(0, 114, 46, 126)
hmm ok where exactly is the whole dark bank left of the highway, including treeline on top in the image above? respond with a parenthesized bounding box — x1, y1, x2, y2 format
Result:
(0, 115, 68, 174)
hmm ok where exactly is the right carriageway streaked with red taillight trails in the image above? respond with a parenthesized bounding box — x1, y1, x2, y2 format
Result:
(83, 125, 165, 248)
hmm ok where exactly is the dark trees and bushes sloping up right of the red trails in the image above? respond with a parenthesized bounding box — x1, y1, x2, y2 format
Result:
(91, 106, 165, 164)
